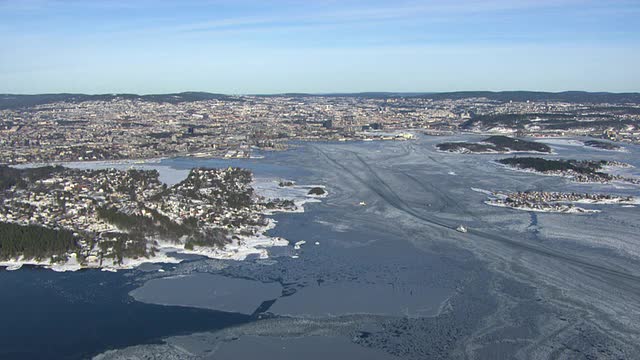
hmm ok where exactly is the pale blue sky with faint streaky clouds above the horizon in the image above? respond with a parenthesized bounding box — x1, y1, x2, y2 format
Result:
(0, 0, 640, 94)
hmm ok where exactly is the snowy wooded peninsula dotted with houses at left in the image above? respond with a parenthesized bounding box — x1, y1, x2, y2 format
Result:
(0, 166, 296, 270)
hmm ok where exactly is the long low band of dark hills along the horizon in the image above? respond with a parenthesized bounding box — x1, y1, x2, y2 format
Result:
(0, 91, 640, 109)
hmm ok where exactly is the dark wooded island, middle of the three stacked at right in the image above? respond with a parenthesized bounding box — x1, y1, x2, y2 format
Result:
(497, 157, 640, 184)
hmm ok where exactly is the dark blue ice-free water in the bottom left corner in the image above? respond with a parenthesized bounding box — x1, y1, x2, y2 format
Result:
(0, 267, 252, 359)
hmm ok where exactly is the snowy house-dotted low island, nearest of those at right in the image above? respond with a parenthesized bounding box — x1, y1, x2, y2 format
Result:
(485, 191, 637, 213)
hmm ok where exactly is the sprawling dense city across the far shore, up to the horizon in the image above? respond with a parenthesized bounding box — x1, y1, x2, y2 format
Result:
(0, 93, 640, 164)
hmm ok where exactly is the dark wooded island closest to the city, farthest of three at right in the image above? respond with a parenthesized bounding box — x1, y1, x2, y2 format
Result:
(436, 135, 551, 154)
